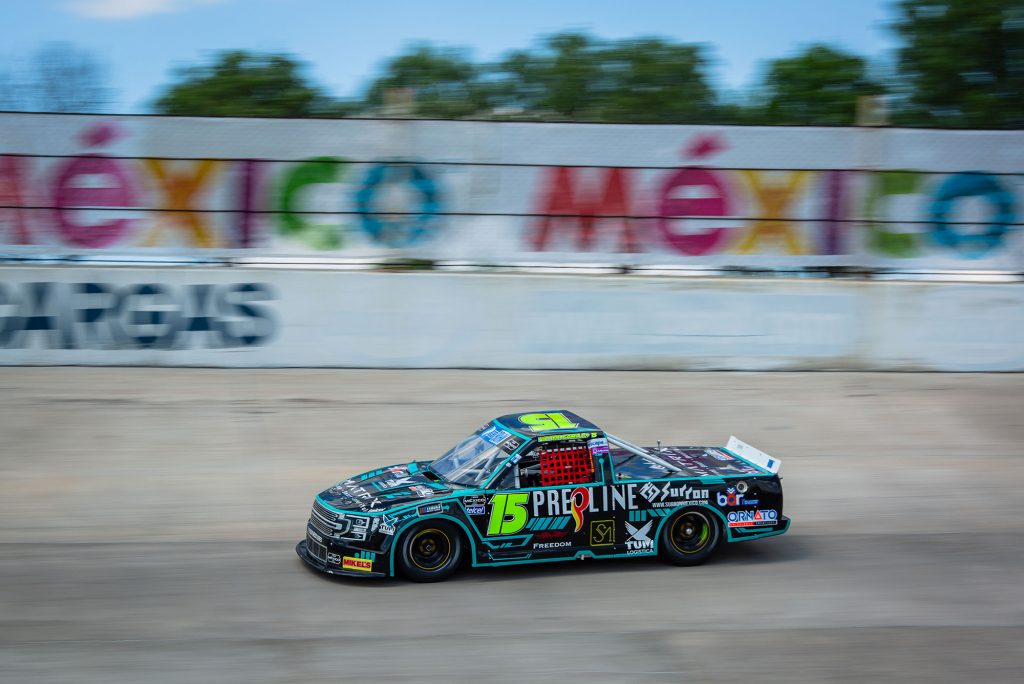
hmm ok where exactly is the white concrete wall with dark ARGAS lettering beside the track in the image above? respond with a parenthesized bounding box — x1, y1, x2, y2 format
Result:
(0, 266, 1024, 371)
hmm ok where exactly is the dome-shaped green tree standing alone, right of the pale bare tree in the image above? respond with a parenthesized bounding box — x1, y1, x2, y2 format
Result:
(154, 50, 335, 118)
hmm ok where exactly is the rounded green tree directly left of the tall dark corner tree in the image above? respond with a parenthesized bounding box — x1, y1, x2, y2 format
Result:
(752, 45, 885, 126)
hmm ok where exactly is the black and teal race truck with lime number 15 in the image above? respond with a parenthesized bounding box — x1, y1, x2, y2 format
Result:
(296, 411, 790, 582)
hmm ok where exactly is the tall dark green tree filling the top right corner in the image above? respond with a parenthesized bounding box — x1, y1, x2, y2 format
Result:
(893, 0, 1024, 128)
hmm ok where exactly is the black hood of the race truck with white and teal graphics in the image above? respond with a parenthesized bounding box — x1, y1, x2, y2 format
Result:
(319, 462, 453, 512)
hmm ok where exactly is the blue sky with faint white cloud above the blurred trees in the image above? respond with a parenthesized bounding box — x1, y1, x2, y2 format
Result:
(0, 0, 895, 113)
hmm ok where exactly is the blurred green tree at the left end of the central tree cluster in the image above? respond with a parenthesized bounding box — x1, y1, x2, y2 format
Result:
(365, 45, 488, 119)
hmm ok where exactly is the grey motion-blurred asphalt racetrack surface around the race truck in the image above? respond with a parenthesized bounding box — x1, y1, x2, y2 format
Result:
(0, 369, 1024, 684)
